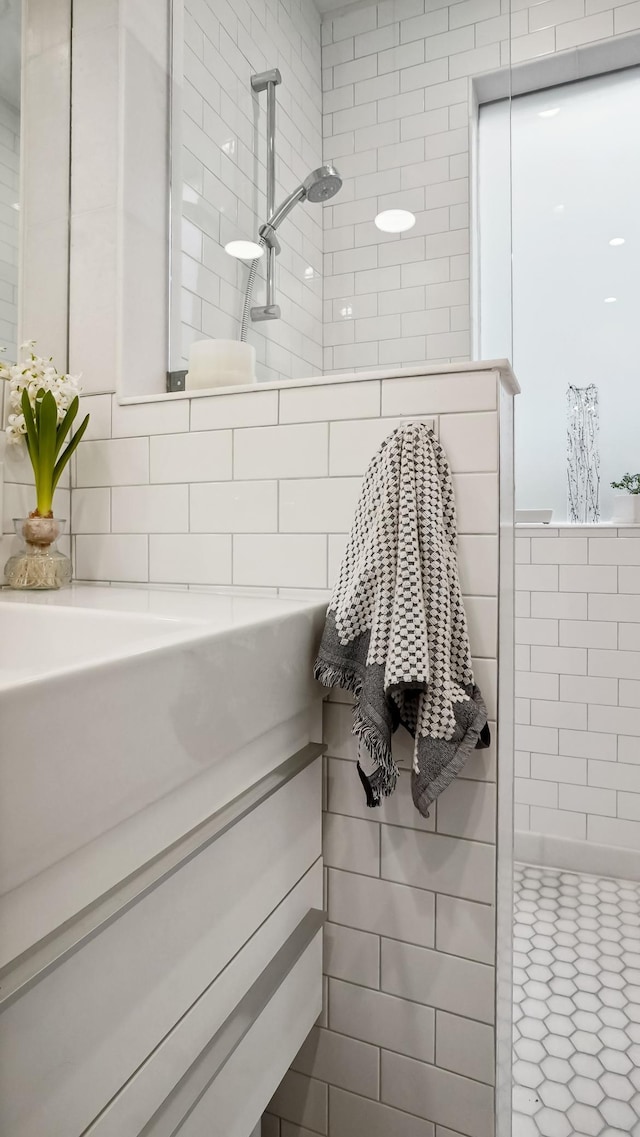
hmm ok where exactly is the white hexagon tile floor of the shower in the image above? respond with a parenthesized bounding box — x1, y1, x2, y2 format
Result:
(513, 864, 640, 1137)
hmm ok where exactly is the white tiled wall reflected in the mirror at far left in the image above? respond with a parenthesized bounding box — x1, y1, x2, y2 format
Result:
(0, 99, 20, 357)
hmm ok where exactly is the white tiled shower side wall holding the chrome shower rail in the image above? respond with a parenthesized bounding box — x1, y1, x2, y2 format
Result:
(174, 0, 323, 381)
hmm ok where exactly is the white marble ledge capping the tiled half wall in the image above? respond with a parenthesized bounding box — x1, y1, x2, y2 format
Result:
(118, 359, 521, 406)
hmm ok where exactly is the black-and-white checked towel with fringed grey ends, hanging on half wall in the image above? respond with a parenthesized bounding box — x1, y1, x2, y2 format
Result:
(314, 422, 490, 818)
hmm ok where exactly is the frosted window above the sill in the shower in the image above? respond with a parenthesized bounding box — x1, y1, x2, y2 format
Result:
(479, 63, 640, 522)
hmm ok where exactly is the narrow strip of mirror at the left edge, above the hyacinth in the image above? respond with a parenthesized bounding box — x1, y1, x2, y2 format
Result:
(0, 0, 20, 360)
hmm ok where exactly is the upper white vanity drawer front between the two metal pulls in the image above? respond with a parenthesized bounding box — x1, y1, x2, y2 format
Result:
(0, 758, 321, 1137)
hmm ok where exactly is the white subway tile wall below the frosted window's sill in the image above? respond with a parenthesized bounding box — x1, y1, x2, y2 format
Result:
(515, 527, 640, 850)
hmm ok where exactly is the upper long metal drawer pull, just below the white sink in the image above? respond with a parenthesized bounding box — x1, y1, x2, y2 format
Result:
(0, 742, 326, 1013)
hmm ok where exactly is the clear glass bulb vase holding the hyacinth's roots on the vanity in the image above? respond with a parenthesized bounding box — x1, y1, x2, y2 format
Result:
(5, 517, 72, 590)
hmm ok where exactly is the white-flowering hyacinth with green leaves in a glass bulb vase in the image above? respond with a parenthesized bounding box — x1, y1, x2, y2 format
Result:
(0, 340, 89, 589)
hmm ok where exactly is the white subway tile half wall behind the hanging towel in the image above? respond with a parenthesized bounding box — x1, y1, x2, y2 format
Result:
(73, 372, 516, 1137)
